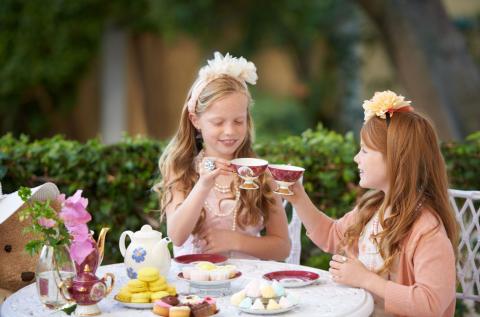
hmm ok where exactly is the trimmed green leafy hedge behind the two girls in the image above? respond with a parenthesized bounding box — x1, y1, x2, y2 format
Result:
(0, 126, 480, 268)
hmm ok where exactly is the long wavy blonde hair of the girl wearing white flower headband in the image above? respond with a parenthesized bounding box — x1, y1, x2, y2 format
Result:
(155, 75, 275, 233)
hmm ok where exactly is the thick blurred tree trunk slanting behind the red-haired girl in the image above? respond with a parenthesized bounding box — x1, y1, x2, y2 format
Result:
(357, 0, 480, 140)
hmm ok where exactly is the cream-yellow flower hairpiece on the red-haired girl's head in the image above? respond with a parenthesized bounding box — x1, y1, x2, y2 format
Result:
(363, 90, 413, 123)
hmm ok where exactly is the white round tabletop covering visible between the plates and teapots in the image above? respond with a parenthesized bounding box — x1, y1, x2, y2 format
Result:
(1, 260, 373, 317)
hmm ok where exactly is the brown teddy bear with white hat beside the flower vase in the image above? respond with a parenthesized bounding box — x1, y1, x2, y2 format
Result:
(0, 183, 59, 305)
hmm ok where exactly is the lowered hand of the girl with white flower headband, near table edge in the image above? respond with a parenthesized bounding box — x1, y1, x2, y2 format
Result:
(198, 228, 237, 253)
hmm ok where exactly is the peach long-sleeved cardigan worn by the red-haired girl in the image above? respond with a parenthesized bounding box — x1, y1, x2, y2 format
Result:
(307, 208, 456, 316)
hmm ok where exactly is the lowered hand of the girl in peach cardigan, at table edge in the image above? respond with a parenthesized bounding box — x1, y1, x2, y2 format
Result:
(328, 254, 375, 288)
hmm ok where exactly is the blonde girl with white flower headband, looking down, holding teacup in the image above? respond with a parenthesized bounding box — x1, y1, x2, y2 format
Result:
(158, 52, 290, 260)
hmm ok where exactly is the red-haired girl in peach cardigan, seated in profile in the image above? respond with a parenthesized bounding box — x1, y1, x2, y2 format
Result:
(285, 91, 458, 316)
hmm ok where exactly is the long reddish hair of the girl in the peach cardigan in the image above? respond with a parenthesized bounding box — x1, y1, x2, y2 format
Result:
(342, 112, 458, 273)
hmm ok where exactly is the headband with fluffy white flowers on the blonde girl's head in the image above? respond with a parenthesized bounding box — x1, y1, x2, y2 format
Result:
(187, 52, 258, 113)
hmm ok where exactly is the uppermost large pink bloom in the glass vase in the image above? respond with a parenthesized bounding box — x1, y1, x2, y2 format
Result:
(57, 190, 92, 228)
